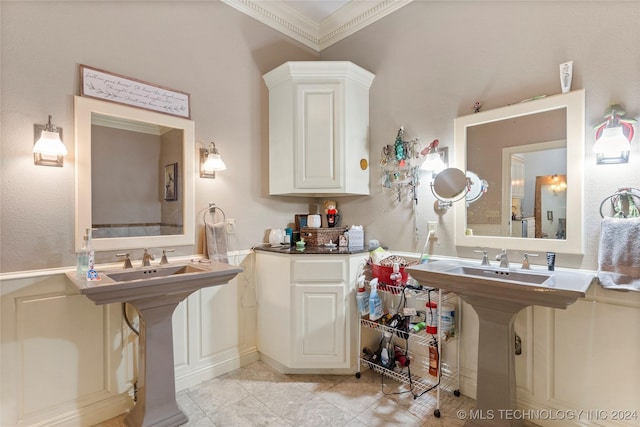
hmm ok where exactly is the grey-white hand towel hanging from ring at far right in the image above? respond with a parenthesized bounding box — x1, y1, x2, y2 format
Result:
(598, 217, 640, 292)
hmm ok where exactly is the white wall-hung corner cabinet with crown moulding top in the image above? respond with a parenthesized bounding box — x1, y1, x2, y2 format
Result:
(263, 61, 374, 197)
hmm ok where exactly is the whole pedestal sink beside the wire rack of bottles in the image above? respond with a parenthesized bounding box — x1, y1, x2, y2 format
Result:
(405, 260, 594, 427)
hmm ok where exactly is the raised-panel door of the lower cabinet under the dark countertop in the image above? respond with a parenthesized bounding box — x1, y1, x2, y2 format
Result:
(292, 283, 349, 368)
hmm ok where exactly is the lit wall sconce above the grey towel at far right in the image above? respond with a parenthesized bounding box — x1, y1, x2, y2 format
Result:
(593, 104, 636, 165)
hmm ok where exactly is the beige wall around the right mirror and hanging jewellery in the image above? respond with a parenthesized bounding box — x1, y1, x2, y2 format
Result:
(321, 1, 640, 269)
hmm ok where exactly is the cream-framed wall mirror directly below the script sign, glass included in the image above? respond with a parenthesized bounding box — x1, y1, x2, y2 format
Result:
(75, 96, 195, 251)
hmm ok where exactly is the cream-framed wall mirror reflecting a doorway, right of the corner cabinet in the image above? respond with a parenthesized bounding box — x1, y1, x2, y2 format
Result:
(454, 90, 585, 254)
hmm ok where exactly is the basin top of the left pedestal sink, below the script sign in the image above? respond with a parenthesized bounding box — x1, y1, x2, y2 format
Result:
(67, 262, 242, 304)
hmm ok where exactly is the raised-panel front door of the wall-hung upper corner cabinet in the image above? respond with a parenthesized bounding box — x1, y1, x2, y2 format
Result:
(294, 83, 344, 190)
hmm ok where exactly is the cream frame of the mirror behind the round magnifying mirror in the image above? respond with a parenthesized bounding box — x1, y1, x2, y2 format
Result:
(454, 89, 585, 254)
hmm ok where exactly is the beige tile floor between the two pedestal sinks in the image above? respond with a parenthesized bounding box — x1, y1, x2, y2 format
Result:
(96, 362, 475, 427)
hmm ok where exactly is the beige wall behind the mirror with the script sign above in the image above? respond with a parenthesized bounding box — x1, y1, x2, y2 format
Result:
(0, 1, 318, 272)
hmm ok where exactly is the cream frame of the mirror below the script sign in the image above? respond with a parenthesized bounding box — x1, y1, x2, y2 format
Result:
(74, 96, 195, 251)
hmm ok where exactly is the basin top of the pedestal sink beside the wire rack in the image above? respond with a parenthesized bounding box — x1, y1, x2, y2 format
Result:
(406, 260, 594, 308)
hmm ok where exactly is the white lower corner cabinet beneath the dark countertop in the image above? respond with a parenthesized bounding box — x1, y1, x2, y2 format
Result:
(256, 251, 367, 373)
